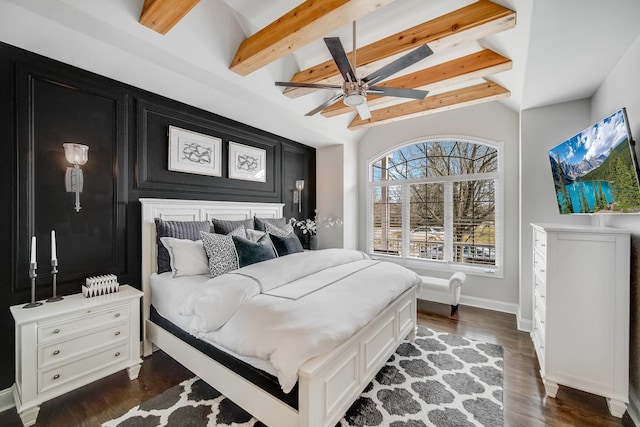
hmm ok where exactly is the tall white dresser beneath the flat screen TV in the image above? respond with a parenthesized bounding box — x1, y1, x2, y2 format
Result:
(531, 224, 631, 417)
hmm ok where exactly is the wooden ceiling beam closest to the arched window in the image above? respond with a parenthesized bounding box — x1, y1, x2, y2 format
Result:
(349, 81, 511, 130)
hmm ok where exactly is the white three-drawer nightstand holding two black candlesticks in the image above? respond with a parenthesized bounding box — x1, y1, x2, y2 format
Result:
(11, 285, 142, 426)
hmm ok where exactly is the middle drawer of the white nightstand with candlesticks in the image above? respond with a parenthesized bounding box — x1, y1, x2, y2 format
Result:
(38, 322, 129, 368)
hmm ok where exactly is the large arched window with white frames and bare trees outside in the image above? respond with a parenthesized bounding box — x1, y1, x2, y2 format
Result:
(367, 138, 502, 273)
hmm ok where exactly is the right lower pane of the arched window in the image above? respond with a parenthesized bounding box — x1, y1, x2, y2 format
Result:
(453, 180, 496, 265)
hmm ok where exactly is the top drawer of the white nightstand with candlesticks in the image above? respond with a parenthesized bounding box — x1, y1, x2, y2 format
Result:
(38, 306, 129, 344)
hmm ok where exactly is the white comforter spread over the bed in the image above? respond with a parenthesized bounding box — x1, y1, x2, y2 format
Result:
(181, 249, 419, 393)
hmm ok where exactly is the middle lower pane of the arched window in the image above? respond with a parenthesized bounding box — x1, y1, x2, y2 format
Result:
(408, 183, 444, 260)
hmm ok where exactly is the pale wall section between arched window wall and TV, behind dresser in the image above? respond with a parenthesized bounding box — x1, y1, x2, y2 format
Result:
(518, 100, 590, 330)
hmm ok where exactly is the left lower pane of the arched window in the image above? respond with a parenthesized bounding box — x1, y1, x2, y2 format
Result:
(372, 185, 402, 256)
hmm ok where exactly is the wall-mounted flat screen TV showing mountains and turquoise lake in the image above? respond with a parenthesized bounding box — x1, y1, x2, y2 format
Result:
(549, 108, 640, 214)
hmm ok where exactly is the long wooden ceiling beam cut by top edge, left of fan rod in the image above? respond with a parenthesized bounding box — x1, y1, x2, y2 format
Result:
(229, 0, 393, 76)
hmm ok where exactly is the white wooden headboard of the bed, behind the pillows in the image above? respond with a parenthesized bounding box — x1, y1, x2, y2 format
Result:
(140, 199, 284, 356)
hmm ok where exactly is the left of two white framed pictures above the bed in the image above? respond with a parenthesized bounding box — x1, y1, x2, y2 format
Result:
(169, 126, 222, 176)
